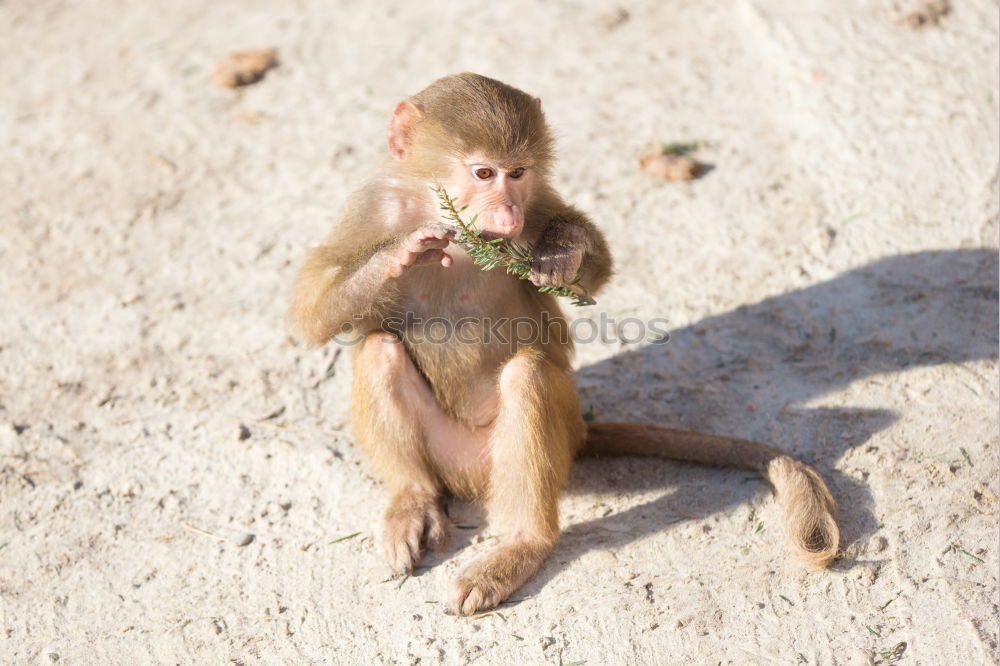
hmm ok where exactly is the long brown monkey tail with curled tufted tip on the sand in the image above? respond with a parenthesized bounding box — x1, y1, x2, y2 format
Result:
(581, 423, 840, 567)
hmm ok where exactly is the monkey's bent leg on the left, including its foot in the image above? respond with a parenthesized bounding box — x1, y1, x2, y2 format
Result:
(351, 333, 448, 573)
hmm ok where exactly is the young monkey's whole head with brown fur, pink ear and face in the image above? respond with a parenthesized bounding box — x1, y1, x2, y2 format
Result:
(388, 73, 553, 238)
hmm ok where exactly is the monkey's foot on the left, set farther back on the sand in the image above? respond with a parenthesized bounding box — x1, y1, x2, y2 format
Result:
(382, 491, 448, 574)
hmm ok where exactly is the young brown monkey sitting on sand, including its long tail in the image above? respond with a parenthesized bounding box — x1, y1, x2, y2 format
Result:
(291, 73, 839, 615)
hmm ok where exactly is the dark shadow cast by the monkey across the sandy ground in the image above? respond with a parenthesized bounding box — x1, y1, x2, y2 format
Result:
(524, 249, 998, 594)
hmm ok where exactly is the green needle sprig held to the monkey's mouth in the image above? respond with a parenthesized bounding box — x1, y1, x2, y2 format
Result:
(433, 183, 597, 307)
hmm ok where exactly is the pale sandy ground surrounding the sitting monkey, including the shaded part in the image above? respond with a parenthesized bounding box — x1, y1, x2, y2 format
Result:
(0, 0, 998, 666)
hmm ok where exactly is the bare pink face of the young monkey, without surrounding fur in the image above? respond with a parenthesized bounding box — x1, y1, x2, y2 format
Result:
(446, 154, 533, 238)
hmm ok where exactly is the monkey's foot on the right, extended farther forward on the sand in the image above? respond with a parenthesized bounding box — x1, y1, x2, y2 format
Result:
(448, 541, 551, 615)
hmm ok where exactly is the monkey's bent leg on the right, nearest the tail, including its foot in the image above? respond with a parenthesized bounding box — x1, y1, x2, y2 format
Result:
(450, 350, 584, 615)
